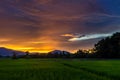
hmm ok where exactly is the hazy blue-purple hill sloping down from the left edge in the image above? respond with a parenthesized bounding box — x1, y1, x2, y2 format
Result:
(0, 47, 26, 57)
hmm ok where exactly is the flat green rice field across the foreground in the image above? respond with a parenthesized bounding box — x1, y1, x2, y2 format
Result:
(0, 59, 120, 80)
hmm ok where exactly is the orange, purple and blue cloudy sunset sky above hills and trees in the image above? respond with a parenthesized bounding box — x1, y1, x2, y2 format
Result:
(0, 0, 120, 52)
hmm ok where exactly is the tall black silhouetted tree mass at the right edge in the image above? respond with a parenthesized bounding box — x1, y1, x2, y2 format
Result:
(95, 32, 120, 58)
